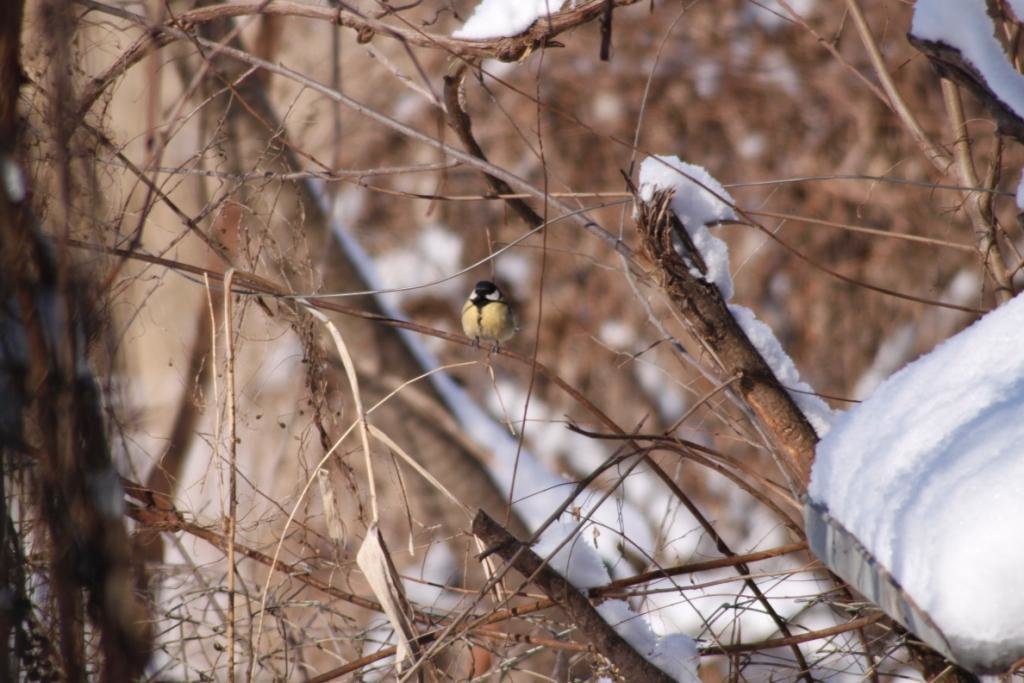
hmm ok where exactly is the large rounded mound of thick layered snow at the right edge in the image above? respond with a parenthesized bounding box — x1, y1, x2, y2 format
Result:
(809, 296, 1024, 670)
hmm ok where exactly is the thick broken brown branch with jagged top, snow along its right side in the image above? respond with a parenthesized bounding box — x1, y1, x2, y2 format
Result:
(635, 157, 830, 490)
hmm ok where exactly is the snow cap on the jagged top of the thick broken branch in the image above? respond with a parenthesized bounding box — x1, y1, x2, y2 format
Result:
(640, 156, 736, 301)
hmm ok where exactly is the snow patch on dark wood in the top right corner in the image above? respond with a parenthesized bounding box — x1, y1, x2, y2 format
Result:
(910, 0, 1024, 118)
